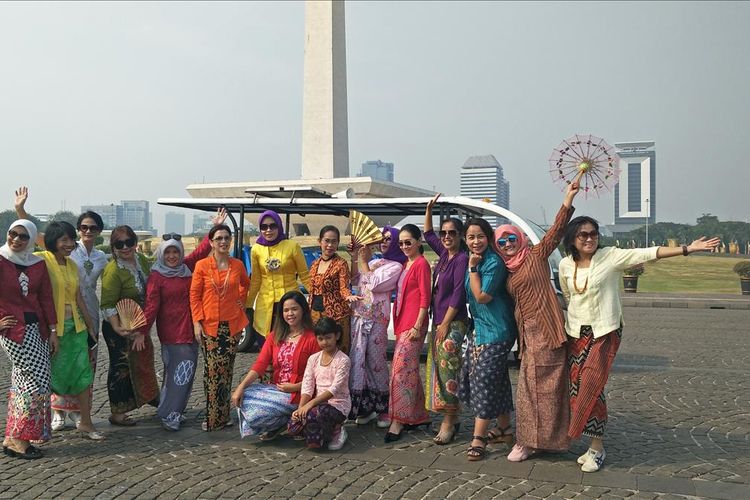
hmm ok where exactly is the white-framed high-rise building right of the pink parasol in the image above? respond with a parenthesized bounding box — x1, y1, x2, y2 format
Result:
(612, 141, 656, 233)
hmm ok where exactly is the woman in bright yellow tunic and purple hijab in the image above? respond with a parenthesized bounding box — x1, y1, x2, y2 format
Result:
(247, 210, 311, 345)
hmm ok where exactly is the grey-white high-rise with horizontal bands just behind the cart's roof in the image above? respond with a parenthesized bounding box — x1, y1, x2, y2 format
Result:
(461, 155, 510, 227)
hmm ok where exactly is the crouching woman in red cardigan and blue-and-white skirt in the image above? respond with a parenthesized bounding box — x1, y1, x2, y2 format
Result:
(232, 290, 320, 441)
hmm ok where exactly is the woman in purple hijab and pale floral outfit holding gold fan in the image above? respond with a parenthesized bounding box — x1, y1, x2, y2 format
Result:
(349, 226, 406, 429)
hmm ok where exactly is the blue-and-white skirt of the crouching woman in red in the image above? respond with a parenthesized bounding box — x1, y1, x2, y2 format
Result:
(237, 384, 297, 437)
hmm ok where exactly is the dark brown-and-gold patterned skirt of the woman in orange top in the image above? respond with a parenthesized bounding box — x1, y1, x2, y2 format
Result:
(202, 321, 240, 431)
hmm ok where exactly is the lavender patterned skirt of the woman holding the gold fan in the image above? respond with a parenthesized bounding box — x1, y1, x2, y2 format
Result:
(349, 316, 389, 419)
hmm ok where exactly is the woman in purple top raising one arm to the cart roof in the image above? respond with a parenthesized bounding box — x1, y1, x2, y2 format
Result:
(424, 193, 469, 445)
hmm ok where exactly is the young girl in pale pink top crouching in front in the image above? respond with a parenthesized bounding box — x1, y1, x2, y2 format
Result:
(289, 317, 352, 450)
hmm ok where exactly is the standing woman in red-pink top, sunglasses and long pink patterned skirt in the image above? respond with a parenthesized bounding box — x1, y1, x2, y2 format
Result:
(385, 224, 431, 443)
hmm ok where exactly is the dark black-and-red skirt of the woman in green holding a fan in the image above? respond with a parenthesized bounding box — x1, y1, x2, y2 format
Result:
(102, 321, 159, 413)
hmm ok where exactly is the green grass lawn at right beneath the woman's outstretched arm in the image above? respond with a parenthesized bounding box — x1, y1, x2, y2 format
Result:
(638, 255, 740, 294)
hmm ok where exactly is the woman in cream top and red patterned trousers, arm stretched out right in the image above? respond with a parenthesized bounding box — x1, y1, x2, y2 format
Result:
(560, 216, 720, 472)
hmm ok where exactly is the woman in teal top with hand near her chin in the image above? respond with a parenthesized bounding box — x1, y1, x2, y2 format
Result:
(459, 218, 517, 461)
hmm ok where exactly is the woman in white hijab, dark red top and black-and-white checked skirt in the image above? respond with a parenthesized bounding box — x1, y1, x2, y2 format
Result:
(0, 220, 58, 459)
